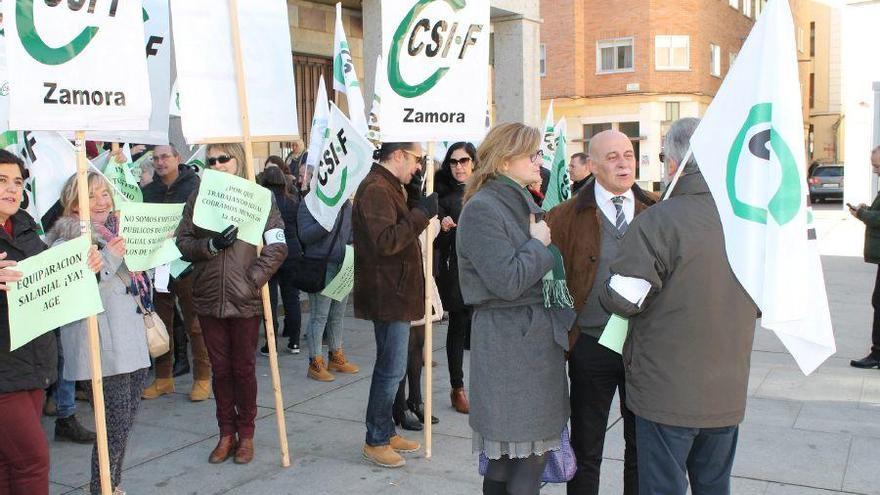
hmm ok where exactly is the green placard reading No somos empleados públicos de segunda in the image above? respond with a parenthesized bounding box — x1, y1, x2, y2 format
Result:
(119, 203, 184, 272)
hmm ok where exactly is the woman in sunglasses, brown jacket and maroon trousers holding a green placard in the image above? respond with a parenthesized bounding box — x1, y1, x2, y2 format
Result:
(177, 144, 287, 464)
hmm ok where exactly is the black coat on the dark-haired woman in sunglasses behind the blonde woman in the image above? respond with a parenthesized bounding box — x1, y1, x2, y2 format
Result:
(434, 166, 466, 311)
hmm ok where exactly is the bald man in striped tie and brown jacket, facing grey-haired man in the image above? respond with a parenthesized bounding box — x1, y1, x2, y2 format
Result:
(547, 130, 655, 495)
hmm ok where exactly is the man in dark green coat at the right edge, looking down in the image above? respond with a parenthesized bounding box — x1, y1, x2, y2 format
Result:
(849, 146, 880, 368)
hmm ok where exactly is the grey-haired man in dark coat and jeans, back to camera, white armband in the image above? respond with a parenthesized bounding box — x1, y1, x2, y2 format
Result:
(599, 118, 758, 495)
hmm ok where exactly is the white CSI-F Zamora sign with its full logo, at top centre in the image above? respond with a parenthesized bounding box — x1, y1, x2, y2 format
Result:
(377, 0, 488, 142)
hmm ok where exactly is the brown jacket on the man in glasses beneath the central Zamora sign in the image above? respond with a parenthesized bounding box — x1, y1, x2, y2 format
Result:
(352, 165, 428, 321)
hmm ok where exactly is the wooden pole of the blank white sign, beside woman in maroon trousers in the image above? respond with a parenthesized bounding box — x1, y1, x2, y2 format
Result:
(229, 0, 290, 467)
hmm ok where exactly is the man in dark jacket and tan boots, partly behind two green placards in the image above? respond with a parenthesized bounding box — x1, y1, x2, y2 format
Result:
(142, 145, 211, 402)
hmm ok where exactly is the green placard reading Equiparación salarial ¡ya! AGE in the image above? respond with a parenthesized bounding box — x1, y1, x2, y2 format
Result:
(7, 237, 104, 351)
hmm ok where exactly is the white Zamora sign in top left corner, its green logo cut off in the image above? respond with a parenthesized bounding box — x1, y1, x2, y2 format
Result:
(3, 0, 151, 131)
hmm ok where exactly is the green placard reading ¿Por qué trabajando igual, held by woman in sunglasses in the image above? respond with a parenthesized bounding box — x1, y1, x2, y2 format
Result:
(193, 170, 272, 246)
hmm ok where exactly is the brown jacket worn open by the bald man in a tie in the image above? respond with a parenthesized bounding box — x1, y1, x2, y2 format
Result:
(546, 181, 657, 349)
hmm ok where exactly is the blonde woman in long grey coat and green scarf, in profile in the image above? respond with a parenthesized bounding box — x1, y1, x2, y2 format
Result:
(456, 124, 575, 495)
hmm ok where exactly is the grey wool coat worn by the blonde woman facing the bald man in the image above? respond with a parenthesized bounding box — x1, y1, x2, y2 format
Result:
(456, 179, 576, 442)
